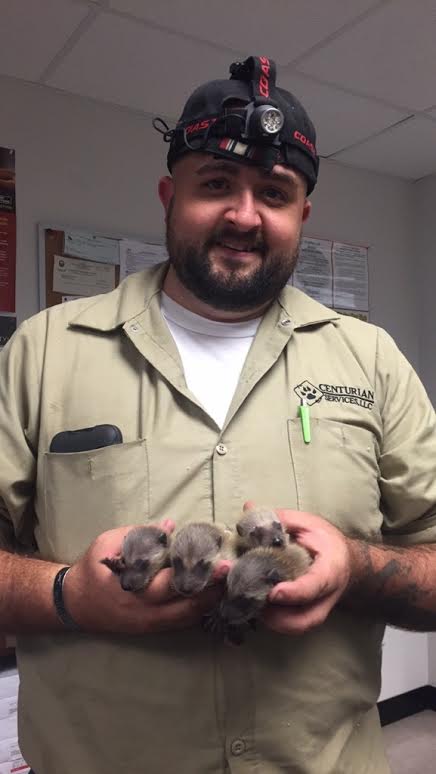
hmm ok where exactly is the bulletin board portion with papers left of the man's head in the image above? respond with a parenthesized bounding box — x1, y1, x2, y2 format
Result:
(38, 223, 167, 309)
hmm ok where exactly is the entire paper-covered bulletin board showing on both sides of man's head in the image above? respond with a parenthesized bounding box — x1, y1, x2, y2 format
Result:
(38, 224, 369, 320)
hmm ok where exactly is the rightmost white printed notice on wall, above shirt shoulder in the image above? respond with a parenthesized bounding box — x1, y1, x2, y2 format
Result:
(333, 242, 369, 311)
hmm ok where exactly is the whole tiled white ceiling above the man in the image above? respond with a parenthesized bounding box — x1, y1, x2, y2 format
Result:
(0, 0, 436, 180)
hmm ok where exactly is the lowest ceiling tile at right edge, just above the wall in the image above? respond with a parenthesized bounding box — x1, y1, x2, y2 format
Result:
(333, 117, 436, 180)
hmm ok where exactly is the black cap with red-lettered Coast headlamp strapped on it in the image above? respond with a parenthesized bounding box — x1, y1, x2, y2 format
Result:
(154, 56, 319, 194)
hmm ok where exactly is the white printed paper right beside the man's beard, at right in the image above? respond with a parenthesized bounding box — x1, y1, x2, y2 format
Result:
(293, 237, 333, 306)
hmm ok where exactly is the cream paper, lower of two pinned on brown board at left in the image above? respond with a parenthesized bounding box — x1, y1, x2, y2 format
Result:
(53, 255, 115, 296)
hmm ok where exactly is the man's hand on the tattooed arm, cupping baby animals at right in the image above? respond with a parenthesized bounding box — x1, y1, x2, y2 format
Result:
(262, 509, 351, 634)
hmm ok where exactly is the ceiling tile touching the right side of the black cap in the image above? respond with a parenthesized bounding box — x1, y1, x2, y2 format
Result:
(279, 73, 407, 156)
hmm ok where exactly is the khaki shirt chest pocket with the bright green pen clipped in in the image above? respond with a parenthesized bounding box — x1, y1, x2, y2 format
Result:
(288, 419, 382, 538)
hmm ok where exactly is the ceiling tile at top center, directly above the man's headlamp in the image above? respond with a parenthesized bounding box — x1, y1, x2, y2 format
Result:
(109, 0, 378, 65)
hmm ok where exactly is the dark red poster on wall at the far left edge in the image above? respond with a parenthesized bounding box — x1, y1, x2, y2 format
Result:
(0, 148, 17, 314)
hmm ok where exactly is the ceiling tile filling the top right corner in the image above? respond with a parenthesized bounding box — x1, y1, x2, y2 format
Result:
(298, 0, 436, 111)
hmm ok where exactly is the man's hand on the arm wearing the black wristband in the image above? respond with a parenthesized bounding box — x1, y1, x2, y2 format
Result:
(64, 521, 225, 634)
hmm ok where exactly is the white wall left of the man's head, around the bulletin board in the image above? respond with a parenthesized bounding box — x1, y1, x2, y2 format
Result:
(0, 78, 165, 319)
